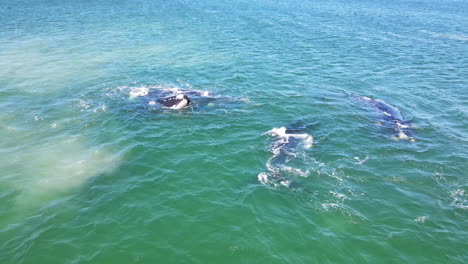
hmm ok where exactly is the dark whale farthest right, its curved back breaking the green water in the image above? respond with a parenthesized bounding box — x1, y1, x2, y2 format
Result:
(355, 96, 416, 142)
